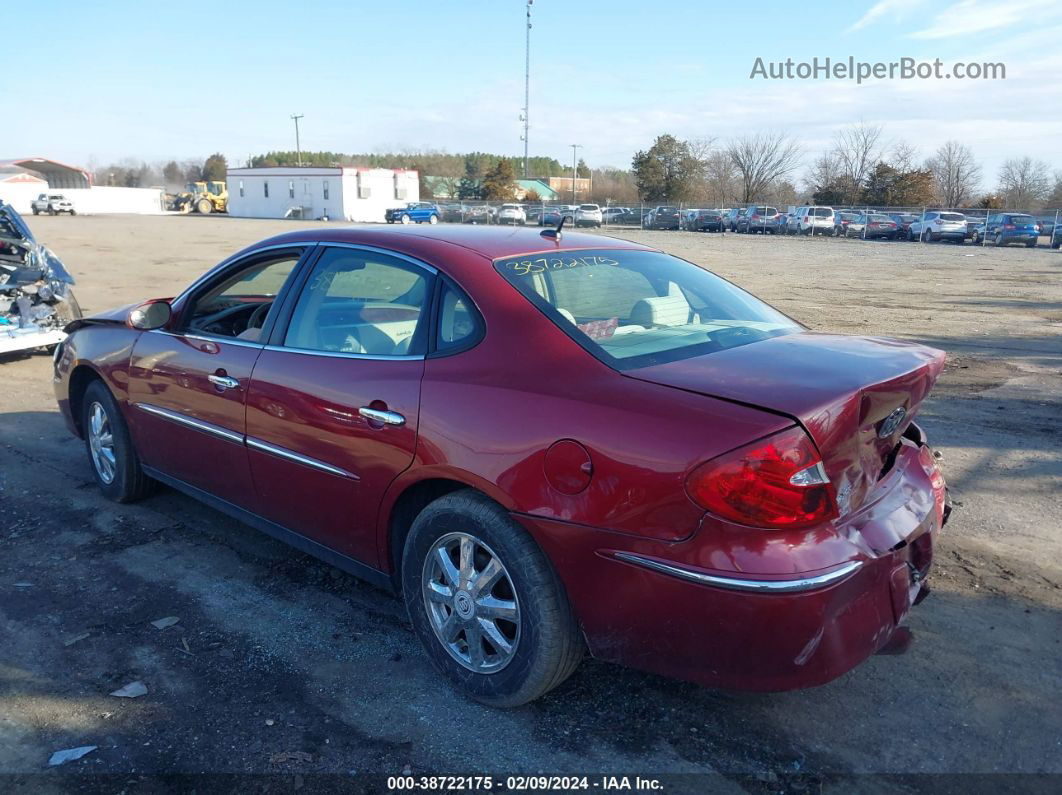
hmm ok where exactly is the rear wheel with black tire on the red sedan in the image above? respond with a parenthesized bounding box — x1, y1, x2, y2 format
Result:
(401, 490, 583, 707)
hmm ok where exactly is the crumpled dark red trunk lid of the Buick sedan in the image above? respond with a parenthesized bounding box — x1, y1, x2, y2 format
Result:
(627, 332, 944, 517)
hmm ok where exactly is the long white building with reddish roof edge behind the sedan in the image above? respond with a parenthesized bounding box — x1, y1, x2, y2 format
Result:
(228, 166, 421, 222)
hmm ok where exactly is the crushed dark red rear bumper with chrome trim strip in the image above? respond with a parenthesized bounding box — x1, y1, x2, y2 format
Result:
(515, 444, 947, 690)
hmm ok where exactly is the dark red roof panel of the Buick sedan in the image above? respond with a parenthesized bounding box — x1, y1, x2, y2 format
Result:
(243, 224, 655, 259)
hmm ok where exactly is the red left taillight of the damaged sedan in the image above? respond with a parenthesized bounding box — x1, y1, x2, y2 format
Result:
(686, 427, 837, 528)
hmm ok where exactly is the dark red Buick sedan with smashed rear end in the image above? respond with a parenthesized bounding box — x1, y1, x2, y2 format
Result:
(55, 226, 947, 706)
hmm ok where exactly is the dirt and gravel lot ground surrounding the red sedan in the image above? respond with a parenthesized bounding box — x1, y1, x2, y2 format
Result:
(0, 217, 1062, 792)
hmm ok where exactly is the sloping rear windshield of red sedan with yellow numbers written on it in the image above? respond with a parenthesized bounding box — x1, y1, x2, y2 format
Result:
(494, 249, 801, 369)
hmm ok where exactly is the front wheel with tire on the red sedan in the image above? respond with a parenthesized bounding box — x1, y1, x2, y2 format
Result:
(81, 381, 154, 502)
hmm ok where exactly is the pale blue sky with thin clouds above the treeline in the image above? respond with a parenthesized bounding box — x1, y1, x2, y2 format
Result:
(0, 0, 1062, 187)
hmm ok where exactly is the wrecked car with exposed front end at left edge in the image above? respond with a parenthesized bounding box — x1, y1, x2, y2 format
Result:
(0, 202, 81, 355)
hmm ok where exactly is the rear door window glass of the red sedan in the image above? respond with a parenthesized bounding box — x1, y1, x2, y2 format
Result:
(284, 247, 429, 357)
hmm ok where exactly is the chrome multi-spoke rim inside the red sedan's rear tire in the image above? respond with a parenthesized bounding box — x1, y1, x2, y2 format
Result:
(421, 533, 520, 674)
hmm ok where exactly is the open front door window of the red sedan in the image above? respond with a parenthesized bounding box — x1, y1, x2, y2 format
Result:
(186, 253, 299, 342)
